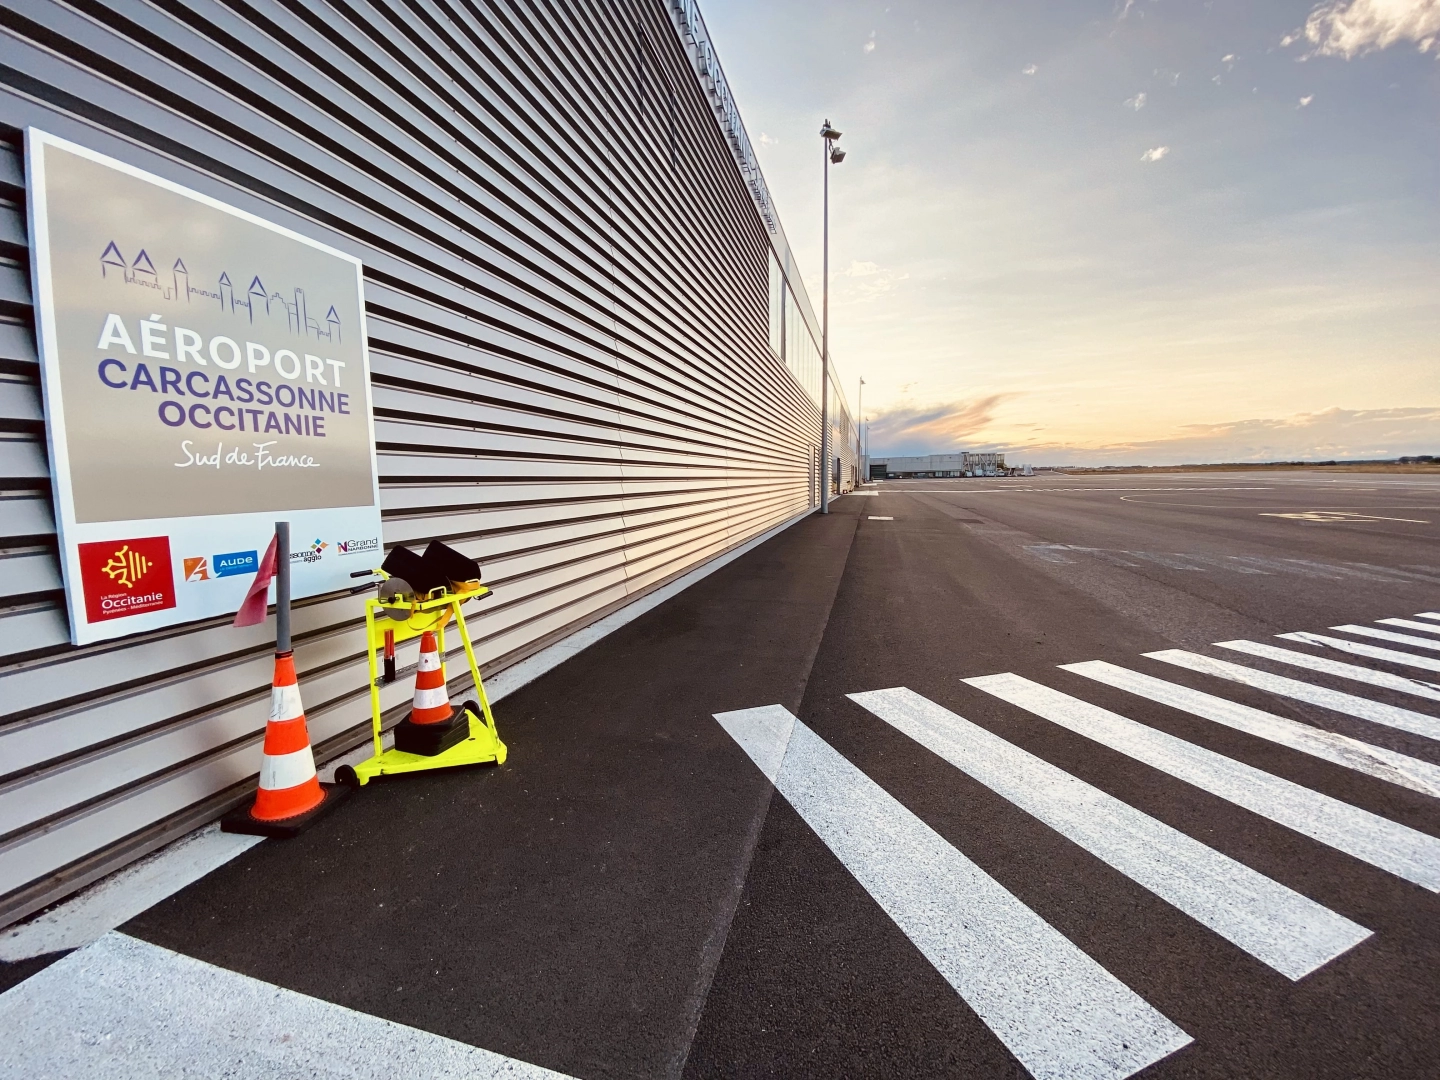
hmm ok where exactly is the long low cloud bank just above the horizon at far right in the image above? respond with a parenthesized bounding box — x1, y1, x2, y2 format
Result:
(1002, 406, 1440, 465)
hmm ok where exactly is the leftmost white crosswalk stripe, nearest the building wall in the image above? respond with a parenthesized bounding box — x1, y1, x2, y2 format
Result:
(716, 706, 1191, 1080)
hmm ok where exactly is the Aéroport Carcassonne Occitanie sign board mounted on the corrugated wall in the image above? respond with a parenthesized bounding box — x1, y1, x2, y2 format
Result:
(26, 128, 382, 645)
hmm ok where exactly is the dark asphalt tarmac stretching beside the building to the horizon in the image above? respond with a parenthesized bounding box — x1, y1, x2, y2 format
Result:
(2, 471, 1440, 1080)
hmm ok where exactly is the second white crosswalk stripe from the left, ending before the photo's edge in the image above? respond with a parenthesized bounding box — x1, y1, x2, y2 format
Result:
(850, 687, 1371, 979)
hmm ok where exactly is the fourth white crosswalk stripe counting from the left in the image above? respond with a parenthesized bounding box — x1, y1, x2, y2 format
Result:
(1061, 654, 1440, 798)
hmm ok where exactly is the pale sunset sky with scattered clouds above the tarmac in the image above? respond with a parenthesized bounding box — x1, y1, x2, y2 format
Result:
(701, 0, 1440, 465)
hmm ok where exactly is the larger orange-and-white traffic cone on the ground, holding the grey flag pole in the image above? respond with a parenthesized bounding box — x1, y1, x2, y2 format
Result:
(220, 652, 348, 837)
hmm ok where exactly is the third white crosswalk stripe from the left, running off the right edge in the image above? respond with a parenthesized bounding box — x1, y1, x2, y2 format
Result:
(965, 674, 1440, 893)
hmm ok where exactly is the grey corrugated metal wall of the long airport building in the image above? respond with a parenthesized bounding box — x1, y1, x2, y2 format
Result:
(0, 0, 854, 924)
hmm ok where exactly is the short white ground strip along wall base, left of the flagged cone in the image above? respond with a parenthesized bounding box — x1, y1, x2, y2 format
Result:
(0, 824, 264, 963)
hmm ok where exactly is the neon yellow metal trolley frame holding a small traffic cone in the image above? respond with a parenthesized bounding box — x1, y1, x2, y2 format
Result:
(354, 585, 505, 786)
